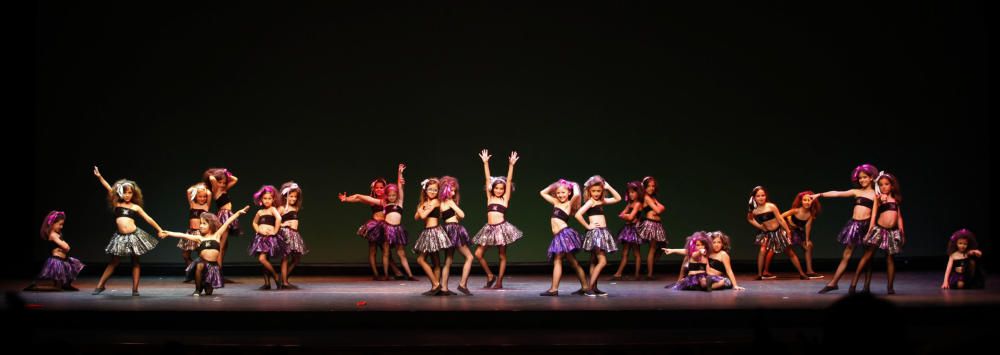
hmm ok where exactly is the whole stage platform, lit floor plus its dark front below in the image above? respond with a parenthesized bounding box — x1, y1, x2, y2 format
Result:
(0, 272, 1000, 354)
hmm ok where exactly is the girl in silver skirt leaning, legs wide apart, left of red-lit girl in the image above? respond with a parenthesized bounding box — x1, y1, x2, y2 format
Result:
(747, 186, 809, 280)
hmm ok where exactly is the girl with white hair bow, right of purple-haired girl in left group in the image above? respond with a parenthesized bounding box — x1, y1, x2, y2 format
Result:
(278, 181, 309, 289)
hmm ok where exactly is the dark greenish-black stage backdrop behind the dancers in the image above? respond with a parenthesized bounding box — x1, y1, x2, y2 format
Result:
(27, 1, 990, 272)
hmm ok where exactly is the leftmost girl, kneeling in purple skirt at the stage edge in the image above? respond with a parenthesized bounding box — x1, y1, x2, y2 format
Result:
(24, 211, 84, 291)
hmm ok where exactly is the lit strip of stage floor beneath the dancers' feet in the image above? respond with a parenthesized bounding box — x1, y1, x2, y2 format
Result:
(3, 272, 1000, 311)
